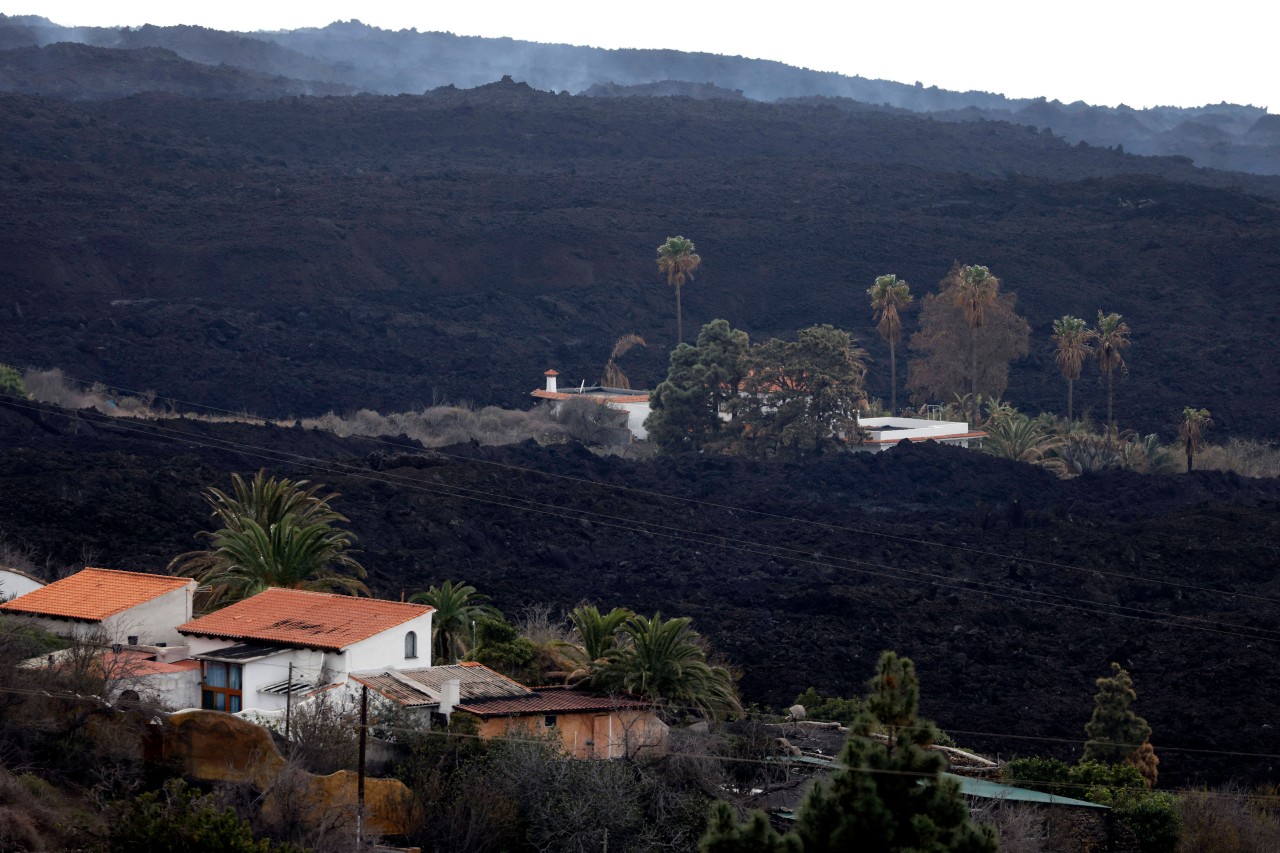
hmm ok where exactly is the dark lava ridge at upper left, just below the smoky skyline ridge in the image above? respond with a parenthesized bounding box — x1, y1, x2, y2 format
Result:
(0, 42, 353, 100)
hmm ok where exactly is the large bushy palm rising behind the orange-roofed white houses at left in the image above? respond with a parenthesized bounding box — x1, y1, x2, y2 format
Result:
(169, 470, 370, 610)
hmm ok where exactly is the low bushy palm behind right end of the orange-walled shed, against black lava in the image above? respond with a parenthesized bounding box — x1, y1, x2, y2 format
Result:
(591, 613, 742, 717)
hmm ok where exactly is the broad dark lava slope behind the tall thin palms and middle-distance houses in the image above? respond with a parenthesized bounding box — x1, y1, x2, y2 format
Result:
(0, 81, 1280, 437)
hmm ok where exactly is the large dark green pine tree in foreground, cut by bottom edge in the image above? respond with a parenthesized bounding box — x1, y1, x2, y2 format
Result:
(701, 652, 997, 853)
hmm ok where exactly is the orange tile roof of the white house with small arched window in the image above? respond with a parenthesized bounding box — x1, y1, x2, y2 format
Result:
(178, 588, 434, 652)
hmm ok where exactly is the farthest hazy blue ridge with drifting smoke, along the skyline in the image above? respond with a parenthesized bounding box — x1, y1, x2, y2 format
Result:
(0, 15, 1280, 174)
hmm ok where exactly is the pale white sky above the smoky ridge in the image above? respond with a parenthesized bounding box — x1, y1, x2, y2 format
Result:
(0, 0, 1280, 113)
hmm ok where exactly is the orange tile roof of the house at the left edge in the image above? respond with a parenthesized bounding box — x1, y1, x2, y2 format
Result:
(0, 569, 196, 622)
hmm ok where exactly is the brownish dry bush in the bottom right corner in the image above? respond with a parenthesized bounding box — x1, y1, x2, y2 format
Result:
(1178, 788, 1280, 853)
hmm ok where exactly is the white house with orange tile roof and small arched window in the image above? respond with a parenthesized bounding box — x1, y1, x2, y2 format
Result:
(178, 589, 434, 713)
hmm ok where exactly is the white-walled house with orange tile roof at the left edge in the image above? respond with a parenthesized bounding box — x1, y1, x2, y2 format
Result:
(0, 569, 196, 646)
